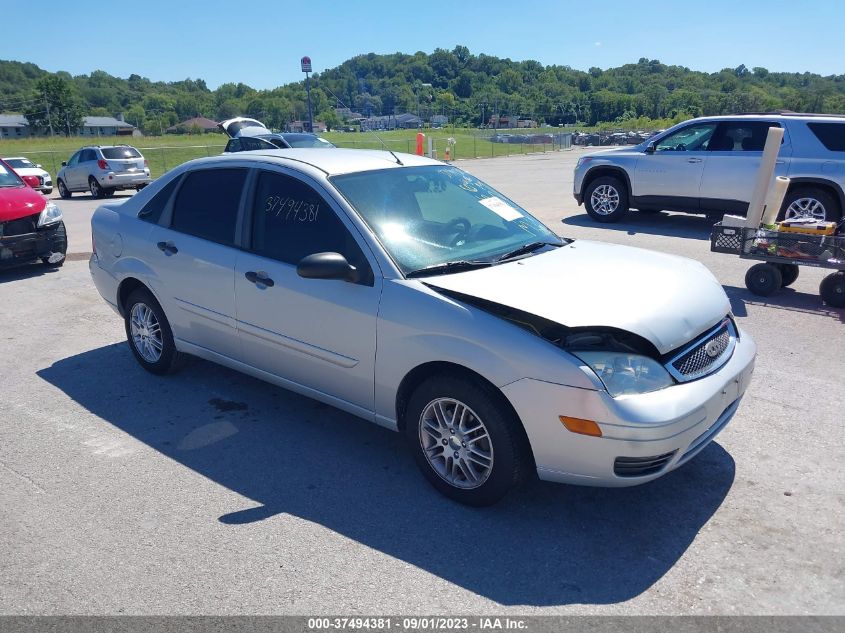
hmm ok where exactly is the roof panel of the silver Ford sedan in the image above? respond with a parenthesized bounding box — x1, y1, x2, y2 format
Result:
(190, 147, 443, 176)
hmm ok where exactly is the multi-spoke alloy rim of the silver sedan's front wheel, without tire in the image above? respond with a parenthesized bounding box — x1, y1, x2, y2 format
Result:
(419, 398, 493, 490)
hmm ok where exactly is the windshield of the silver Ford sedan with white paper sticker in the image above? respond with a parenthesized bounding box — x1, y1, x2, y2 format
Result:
(331, 165, 562, 274)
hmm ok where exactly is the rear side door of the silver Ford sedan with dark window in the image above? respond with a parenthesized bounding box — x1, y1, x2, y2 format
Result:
(144, 167, 249, 360)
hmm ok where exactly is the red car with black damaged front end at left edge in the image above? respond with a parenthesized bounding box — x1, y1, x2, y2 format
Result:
(0, 159, 67, 269)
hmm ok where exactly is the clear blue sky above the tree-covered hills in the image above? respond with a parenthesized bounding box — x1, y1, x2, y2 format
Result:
(0, 0, 845, 89)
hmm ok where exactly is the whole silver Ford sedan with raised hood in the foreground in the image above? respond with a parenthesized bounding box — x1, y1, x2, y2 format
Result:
(90, 149, 755, 505)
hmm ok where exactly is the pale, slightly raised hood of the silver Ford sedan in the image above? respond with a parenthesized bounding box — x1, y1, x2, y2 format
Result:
(425, 240, 730, 354)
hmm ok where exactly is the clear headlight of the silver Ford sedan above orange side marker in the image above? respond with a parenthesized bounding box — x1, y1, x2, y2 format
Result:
(573, 351, 674, 398)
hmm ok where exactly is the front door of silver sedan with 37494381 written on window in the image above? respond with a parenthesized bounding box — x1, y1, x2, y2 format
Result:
(235, 170, 382, 414)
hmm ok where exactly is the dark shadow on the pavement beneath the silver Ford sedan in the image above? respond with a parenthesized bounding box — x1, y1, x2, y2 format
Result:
(38, 343, 735, 606)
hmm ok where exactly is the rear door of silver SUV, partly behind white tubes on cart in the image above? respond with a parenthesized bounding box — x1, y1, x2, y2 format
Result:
(701, 120, 792, 214)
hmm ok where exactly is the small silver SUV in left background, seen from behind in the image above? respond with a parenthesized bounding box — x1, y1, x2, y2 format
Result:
(56, 145, 152, 198)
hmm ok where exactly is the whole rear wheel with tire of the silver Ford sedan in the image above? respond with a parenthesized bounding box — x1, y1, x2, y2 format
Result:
(123, 288, 180, 375)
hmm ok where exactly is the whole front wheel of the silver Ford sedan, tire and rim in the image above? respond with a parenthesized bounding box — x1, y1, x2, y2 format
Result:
(405, 374, 532, 506)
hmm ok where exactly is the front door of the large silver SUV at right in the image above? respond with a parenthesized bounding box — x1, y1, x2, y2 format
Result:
(631, 121, 717, 211)
